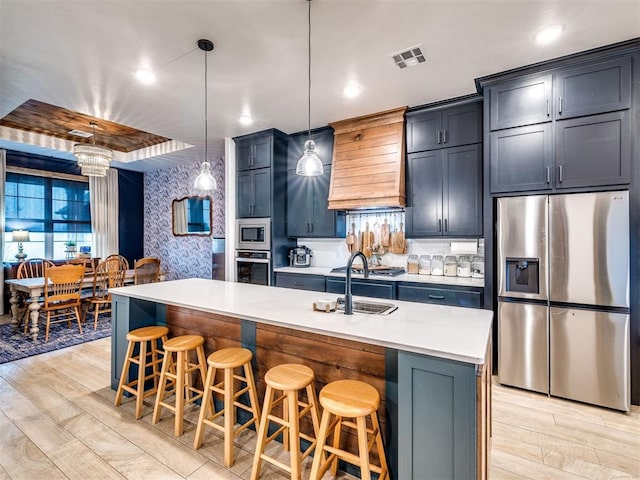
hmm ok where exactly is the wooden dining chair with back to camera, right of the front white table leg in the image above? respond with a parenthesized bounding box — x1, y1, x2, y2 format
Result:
(40, 265, 84, 342)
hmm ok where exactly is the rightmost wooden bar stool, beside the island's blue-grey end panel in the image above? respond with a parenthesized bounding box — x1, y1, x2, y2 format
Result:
(309, 380, 389, 480)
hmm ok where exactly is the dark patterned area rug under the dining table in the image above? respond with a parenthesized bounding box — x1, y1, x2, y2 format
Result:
(0, 315, 111, 363)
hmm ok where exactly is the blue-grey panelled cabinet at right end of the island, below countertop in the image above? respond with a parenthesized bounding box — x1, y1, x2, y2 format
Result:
(398, 350, 491, 480)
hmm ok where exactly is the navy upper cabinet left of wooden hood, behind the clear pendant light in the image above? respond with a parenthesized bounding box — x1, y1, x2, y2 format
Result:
(287, 127, 345, 238)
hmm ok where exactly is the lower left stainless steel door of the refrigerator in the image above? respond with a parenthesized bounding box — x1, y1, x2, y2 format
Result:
(498, 302, 549, 393)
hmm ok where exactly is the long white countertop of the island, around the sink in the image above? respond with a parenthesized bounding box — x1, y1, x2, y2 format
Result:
(110, 278, 493, 365)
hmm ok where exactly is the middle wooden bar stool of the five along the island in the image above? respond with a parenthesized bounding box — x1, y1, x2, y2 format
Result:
(193, 348, 260, 467)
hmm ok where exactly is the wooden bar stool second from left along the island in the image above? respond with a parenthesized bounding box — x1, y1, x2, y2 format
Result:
(153, 335, 206, 437)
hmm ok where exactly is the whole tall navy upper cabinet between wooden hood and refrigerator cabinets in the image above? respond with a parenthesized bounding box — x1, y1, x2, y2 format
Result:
(406, 98, 482, 238)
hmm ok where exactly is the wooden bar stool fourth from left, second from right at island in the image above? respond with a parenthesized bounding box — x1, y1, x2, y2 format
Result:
(251, 363, 320, 480)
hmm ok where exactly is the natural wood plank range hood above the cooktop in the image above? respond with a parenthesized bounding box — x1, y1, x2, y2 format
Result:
(329, 107, 407, 210)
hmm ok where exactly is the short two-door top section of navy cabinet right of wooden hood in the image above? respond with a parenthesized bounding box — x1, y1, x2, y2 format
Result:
(406, 102, 482, 153)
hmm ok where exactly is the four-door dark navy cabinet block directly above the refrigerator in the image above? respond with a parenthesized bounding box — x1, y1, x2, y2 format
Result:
(485, 56, 632, 193)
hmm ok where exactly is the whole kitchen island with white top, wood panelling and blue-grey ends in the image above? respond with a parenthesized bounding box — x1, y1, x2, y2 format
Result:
(111, 279, 493, 479)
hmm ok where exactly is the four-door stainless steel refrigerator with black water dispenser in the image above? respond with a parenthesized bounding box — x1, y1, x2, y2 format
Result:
(497, 191, 631, 411)
